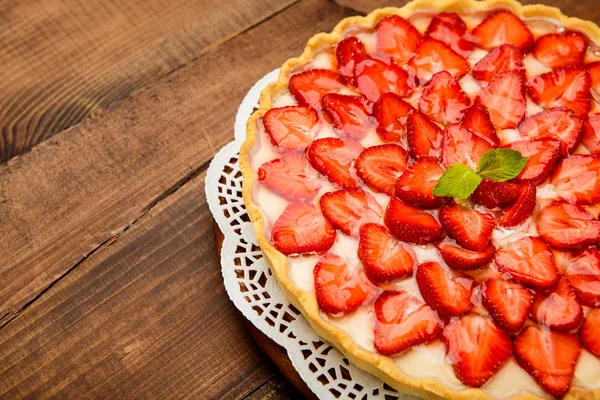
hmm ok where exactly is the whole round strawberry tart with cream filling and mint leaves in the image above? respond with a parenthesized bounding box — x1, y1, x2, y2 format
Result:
(240, 0, 600, 399)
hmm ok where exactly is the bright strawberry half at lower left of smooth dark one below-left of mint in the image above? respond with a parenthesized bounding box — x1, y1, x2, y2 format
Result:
(358, 223, 417, 283)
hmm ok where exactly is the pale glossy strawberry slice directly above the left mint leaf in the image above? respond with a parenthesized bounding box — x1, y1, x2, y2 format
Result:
(442, 124, 492, 170)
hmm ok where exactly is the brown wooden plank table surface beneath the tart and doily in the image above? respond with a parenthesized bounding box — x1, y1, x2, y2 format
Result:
(0, 0, 600, 399)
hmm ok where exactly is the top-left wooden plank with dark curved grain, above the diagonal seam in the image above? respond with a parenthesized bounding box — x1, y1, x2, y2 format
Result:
(0, 0, 296, 162)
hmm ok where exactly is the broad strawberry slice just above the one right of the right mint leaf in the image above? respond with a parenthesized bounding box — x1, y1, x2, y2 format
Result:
(517, 107, 583, 155)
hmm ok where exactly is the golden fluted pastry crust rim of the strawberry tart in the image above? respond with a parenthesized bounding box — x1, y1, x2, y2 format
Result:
(239, 0, 600, 400)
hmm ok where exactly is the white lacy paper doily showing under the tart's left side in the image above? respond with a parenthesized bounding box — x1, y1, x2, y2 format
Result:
(206, 69, 416, 400)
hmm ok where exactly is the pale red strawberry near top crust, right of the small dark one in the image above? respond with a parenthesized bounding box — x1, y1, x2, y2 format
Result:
(375, 15, 421, 65)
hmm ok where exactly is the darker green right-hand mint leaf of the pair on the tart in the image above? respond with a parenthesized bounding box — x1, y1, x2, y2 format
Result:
(477, 149, 527, 182)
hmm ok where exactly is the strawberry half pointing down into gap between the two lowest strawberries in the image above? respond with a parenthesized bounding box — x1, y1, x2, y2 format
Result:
(481, 279, 533, 332)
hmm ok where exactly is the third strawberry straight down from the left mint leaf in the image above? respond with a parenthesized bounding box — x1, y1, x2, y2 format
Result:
(415, 262, 473, 317)
